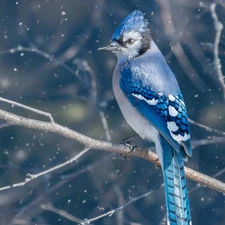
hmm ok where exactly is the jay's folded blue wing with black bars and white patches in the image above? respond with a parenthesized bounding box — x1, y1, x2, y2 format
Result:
(120, 63, 192, 159)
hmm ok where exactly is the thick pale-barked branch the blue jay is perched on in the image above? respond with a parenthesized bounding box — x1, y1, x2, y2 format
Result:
(0, 109, 225, 194)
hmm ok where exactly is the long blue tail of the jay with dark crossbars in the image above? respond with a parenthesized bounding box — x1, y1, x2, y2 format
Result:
(160, 134, 192, 225)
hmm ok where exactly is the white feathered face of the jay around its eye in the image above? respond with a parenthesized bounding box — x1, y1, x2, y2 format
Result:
(115, 31, 142, 58)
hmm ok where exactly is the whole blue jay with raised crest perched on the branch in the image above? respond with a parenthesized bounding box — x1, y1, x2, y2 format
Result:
(99, 10, 192, 225)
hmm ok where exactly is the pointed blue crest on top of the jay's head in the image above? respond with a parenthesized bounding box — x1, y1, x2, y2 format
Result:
(112, 10, 148, 40)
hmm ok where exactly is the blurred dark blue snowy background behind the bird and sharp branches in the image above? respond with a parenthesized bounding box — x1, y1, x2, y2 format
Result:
(0, 0, 225, 225)
